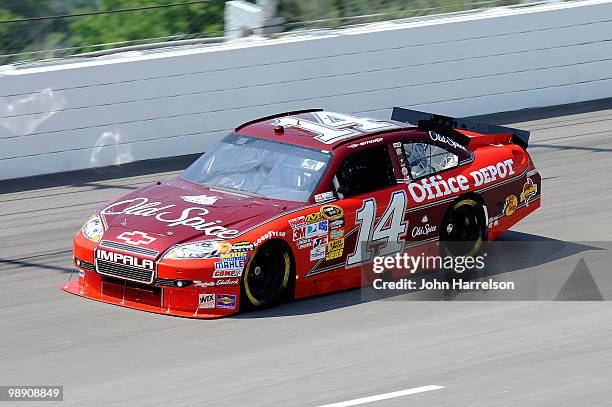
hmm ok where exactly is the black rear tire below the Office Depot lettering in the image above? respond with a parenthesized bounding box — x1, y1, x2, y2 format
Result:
(440, 198, 487, 257)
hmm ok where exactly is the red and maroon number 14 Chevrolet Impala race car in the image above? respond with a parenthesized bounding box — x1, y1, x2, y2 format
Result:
(63, 108, 541, 318)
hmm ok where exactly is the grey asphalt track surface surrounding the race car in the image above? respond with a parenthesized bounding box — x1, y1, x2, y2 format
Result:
(0, 100, 612, 407)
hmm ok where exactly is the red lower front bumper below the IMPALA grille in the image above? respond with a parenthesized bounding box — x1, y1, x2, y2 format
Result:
(61, 269, 240, 319)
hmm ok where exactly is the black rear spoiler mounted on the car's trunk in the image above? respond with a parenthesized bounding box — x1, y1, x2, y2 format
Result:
(391, 107, 530, 150)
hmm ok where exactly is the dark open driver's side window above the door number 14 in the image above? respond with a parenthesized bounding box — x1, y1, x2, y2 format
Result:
(334, 145, 397, 198)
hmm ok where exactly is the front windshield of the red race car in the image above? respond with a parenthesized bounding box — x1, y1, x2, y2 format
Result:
(182, 134, 330, 202)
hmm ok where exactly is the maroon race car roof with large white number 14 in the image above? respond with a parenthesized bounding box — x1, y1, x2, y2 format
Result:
(236, 109, 406, 150)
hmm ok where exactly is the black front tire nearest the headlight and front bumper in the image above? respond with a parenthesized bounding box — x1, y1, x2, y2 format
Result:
(242, 242, 292, 309)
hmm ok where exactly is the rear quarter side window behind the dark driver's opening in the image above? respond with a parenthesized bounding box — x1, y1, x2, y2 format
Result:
(404, 143, 459, 179)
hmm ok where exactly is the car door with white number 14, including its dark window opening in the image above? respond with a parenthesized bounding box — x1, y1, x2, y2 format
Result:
(306, 142, 407, 286)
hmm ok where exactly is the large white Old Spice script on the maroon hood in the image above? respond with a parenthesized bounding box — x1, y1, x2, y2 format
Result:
(100, 198, 240, 239)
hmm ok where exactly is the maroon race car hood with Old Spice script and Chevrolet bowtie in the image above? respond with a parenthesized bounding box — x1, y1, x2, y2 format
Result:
(100, 178, 304, 252)
